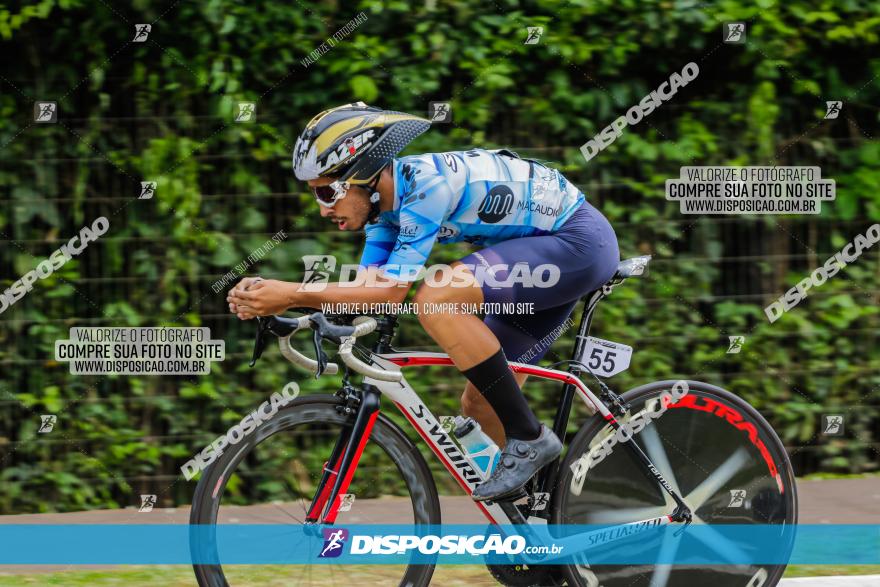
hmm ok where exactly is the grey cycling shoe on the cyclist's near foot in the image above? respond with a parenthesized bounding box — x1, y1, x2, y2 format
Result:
(471, 425, 562, 501)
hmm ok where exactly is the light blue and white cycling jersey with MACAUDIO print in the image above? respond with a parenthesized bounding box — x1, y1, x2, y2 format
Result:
(360, 149, 585, 281)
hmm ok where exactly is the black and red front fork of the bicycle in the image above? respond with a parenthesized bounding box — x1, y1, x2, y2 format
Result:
(305, 385, 380, 524)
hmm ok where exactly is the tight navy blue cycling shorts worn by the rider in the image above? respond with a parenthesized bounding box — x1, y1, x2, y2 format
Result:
(461, 201, 620, 363)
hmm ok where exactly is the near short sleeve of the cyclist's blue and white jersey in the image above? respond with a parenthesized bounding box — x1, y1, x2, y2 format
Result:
(383, 165, 453, 281)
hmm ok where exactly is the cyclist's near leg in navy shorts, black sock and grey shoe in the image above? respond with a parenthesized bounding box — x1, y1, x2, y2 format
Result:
(416, 203, 619, 499)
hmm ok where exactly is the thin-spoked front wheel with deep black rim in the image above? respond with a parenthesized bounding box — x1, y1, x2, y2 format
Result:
(190, 396, 440, 587)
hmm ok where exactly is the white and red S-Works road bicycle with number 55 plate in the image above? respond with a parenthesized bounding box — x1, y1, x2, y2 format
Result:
(190, 257, 797, 587)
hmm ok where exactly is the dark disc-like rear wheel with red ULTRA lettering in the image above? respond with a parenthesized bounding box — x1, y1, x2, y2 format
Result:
(552, 381, 797, 587)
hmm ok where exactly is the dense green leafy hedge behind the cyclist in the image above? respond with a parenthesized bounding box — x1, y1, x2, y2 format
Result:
(0, 0, 880, 513)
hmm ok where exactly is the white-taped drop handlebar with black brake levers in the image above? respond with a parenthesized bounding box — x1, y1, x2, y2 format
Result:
(251, 312, 403, 381)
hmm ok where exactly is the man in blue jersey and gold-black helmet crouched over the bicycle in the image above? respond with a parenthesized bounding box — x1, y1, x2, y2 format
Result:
(227, 102, 620, 501)
